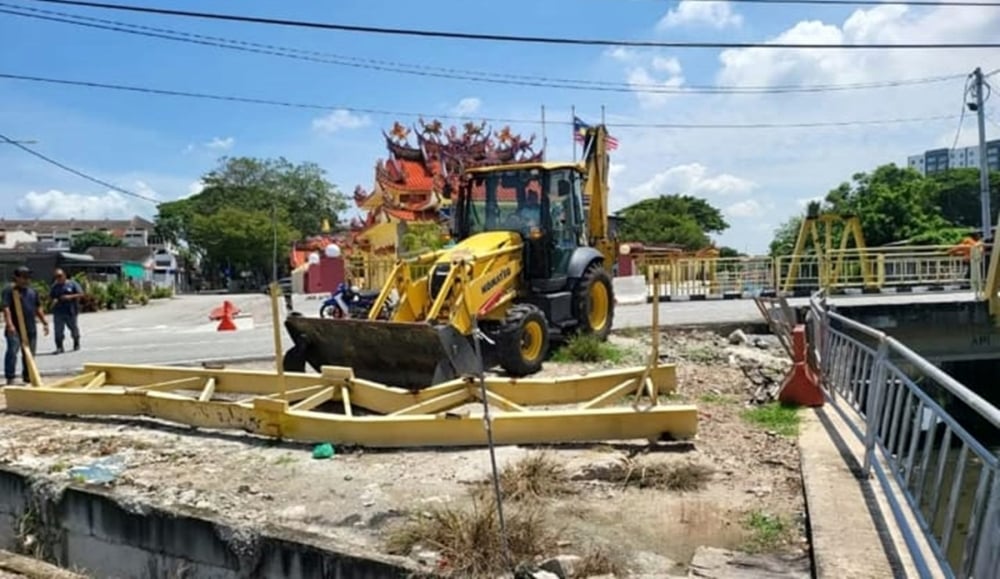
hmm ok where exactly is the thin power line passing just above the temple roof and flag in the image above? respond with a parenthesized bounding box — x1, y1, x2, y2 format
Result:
(0, 73, 957, 129)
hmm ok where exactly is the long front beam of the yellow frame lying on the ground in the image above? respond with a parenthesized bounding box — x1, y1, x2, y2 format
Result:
(4, 386, 698, 447)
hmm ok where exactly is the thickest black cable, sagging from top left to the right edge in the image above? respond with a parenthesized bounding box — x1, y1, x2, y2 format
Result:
(23, 0, 1000, 50)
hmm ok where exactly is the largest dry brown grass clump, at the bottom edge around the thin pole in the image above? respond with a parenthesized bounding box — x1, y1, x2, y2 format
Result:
(386, 497, 558, 578)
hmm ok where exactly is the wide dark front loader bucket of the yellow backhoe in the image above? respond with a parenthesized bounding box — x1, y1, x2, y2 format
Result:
(285, 315, 479, 390)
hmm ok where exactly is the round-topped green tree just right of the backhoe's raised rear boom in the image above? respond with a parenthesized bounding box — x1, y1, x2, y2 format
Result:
(616, 195, 729, 250)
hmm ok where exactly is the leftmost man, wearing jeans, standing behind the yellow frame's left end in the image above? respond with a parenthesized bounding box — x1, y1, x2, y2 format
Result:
(3, 265, 49, 385)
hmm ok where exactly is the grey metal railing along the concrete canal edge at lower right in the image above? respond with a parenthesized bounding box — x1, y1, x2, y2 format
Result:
(808, 292, 1000, 579)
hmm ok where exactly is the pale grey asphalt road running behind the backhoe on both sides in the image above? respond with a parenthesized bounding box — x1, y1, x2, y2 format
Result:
(25, 292, 972, 375)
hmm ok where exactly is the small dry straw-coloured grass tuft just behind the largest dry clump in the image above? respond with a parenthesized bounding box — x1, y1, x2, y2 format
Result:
(477, 452, 570, 501)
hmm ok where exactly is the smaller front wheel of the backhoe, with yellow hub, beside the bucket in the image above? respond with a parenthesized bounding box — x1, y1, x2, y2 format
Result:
(496, 304, 549, 376)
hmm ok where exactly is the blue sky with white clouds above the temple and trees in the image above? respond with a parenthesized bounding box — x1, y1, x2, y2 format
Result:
(0, 0, 1000, 252)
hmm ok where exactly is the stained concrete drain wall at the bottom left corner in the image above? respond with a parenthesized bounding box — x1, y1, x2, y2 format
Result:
(0, 467, 419, 579)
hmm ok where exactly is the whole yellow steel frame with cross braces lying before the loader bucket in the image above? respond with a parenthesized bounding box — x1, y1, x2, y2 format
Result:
(4, 364, 698, 448)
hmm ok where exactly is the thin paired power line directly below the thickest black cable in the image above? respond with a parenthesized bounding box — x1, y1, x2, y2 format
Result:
(0, 2, 965, 94)
